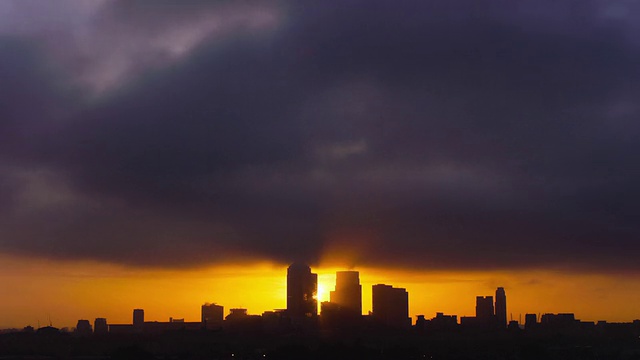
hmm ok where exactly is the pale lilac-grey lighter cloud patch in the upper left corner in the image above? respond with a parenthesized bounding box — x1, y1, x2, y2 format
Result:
(0, 0, 281, 95)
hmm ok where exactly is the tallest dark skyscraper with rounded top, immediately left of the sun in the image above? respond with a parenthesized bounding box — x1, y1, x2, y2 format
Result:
(287, 264, 318, 317)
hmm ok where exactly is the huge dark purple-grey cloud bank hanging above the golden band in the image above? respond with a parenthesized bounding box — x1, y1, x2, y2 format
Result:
(2, 1, 640, 269)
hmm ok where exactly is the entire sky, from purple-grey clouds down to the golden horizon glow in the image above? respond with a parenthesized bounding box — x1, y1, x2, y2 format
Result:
(0, 0, 640, 327)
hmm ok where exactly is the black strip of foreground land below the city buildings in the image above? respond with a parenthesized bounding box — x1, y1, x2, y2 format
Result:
(0, 330, 640, 360)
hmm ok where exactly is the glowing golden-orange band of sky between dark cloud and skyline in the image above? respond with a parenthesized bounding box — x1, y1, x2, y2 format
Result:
(0, 253, 640, 328)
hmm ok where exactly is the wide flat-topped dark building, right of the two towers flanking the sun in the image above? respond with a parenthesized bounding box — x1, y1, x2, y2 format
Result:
(372, 284, 411, 328)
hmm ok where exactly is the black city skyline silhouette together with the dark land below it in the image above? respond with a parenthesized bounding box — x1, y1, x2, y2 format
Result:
(0, 262, 640, 360)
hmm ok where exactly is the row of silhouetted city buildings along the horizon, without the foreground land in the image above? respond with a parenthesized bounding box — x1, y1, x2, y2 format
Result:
(22, 264, 640, 335)
